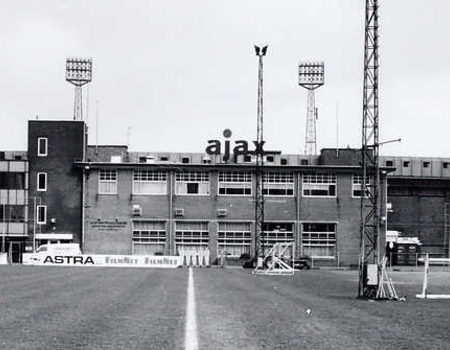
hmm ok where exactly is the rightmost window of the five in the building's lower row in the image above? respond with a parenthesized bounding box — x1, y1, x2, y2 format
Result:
(302, 222, 337, 259)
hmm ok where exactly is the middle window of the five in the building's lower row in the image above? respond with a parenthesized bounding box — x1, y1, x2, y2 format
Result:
(217, 222, 252, 257)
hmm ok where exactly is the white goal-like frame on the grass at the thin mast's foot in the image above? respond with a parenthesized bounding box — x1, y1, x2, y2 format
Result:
(252, 242, 295, 275)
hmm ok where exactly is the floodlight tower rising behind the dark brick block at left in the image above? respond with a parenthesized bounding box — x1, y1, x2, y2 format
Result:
(66, 58, 92, 120)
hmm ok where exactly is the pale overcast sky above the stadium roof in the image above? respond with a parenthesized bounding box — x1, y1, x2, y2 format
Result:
(0, 0, 450, 157)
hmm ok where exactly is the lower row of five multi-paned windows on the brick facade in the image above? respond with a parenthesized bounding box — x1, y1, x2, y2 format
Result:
(132, 221, 337, 258)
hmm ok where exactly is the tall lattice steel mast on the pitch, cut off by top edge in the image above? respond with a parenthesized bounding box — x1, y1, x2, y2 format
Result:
(358, 0, 384, 299)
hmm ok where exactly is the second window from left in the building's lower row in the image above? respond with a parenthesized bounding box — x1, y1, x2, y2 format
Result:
(175, 221, 209, 253)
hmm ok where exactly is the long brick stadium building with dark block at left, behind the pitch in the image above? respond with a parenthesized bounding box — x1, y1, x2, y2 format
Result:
(0, 121, 450, 266)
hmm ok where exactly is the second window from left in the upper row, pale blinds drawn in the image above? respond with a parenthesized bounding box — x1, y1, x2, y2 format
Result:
(133, 170, 167, 194)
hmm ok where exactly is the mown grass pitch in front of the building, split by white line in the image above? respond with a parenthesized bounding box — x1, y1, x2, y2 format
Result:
(0, 266, 450, 350)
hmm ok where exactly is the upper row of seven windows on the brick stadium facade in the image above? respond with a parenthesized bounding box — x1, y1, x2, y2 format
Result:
(98, 169, 368, 197)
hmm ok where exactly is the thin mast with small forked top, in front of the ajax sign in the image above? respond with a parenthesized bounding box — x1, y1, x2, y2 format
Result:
(255, 46, 267, 259)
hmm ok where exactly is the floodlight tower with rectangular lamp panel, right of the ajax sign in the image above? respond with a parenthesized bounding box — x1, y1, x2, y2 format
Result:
(298, 62, 325, 155)
